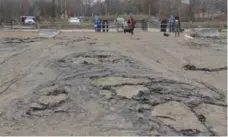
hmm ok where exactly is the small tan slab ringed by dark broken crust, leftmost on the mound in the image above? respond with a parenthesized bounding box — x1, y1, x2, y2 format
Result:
(38, 94, 68, 107)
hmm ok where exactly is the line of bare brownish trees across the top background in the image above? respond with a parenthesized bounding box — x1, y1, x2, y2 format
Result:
(0, 0, 227, 20)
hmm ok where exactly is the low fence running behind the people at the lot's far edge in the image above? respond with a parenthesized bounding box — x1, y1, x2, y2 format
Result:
(0, 20, 227, 30)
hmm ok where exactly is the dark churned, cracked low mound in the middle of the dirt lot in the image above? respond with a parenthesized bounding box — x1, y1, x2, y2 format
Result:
(7, 50, 227, 135)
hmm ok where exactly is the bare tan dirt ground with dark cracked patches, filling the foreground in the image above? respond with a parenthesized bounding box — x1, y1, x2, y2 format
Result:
(0, 32, 227, 136)
